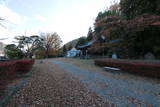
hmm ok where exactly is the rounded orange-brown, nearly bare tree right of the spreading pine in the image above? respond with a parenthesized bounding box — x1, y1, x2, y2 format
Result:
(41, 33, 62, 58)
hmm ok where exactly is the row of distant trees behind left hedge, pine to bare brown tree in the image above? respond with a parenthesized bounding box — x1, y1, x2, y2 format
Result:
(5, 32, 62, 59)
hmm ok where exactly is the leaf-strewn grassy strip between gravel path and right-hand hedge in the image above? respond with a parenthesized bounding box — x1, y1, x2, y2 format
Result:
(56, 58, 160, 84)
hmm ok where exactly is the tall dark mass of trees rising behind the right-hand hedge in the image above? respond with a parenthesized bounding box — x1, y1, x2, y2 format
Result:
(64, 0, 160, 59)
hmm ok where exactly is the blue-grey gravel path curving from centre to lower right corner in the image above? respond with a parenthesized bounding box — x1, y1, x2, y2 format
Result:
(52, 60, 160, 107)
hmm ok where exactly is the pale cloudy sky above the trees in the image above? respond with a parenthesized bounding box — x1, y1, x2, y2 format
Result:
(0, 0, 119, 44)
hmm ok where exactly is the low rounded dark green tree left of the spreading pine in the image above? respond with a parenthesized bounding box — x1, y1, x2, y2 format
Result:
(5, 44, 24, 59)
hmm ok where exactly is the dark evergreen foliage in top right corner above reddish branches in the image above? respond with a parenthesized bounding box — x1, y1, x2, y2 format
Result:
(120, 0, 160, 19)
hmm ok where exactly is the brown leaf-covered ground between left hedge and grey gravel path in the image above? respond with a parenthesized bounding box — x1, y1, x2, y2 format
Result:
(7, 61, 114, 107)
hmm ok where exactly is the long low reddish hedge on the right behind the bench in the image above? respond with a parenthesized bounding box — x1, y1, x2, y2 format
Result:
(95, 58, 160, 78)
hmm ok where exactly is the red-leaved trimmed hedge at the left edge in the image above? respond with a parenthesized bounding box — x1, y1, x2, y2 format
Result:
(0, 59, 34, 97)
